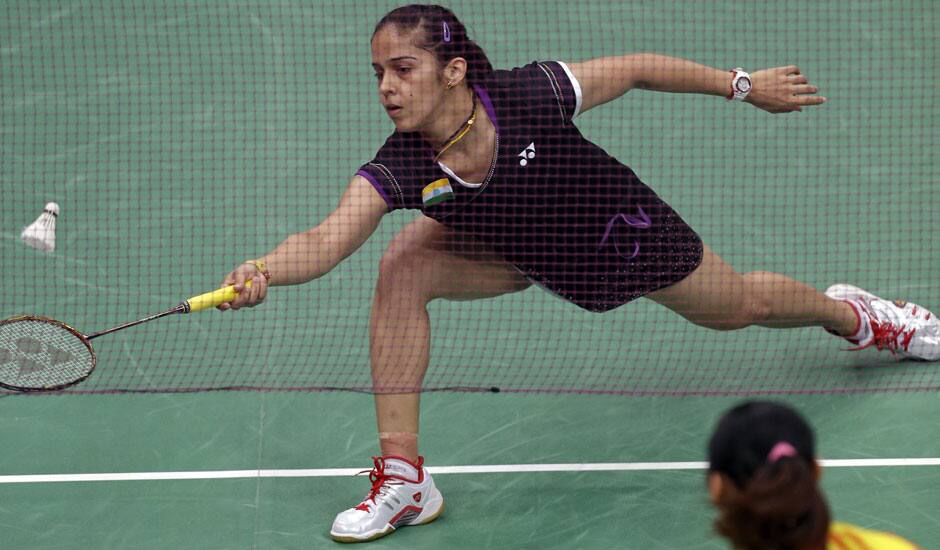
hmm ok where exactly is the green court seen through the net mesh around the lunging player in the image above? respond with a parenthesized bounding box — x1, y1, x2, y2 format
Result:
(0, 0, 940, 395)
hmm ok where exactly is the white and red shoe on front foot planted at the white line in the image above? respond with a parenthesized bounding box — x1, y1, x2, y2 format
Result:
(330, 456, 444, 542)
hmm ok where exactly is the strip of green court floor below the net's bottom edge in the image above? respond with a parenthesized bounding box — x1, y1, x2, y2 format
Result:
(0, 393, 940, 550)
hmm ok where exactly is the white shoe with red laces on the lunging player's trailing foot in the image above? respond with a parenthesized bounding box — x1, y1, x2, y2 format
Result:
(826, 285, 940, 361)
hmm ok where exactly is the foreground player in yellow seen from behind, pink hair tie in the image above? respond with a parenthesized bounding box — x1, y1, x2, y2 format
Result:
(708, 401, 917, 550)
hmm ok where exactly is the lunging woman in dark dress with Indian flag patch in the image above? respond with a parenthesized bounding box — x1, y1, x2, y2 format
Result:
(215, 5, 940, 541)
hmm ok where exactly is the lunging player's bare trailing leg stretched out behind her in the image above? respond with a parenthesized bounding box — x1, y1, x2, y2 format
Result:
(647, 246, 858, 336)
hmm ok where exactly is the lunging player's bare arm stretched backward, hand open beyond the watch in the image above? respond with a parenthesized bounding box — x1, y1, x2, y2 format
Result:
(568, 53, 826, 113)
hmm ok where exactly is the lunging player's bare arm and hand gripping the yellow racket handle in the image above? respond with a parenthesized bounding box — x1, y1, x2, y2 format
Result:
(219, 176, 388, 310)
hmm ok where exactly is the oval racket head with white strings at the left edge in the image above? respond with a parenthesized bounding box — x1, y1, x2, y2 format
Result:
(0, 315, 96, 392)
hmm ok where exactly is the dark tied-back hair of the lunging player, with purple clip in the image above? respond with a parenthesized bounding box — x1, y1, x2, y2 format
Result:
(372, 4, 493, 86)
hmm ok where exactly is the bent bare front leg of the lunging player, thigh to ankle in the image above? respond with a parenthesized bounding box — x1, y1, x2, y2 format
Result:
(369, 217, 529, 461)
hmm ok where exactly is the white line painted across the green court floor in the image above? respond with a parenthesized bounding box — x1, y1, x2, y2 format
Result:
(0, 458, 940, 484)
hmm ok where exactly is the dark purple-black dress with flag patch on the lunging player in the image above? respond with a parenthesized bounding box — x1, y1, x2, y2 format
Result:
(358, 61, 702, 312)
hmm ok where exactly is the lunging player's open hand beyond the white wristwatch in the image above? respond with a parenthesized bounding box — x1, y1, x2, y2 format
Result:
(744, 65, 826, 113)
